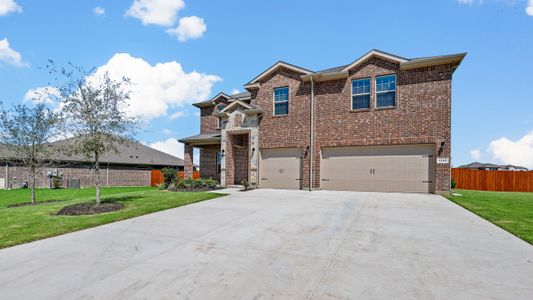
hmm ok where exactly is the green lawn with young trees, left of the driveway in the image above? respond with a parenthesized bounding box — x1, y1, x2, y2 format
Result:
(0, 187, 223, 249)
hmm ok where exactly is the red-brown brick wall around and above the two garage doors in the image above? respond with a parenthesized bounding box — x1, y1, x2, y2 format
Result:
(252, 58, 452, 191)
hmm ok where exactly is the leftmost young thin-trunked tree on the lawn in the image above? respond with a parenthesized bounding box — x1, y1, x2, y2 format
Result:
(0, 102, 60, 203)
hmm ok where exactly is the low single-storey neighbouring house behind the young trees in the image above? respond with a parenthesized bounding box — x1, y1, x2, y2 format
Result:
(0, 140, 183, 188)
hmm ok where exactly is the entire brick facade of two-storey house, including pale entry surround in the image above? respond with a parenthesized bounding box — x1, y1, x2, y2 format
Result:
(190, 51, 462, 192)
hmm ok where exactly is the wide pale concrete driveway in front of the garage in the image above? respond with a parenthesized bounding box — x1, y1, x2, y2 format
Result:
(0, 190, 533, 299)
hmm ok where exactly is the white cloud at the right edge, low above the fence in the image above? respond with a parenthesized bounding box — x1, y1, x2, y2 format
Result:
(488, 130, 533, 169)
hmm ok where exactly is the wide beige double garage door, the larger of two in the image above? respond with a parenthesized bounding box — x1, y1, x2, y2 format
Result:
(320, 145, 433, 193)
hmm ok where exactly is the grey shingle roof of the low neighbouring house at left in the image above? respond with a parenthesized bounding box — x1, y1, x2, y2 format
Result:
(0, 139, 184, 167)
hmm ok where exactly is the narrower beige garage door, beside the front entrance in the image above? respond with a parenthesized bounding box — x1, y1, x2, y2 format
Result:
(259, 148, 302, 189)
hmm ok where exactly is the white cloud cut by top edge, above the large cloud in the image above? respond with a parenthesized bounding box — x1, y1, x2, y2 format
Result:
(126, 0, 185, 26)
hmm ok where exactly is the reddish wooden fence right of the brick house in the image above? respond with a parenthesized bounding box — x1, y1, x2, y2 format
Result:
(452, 169, 533, 192)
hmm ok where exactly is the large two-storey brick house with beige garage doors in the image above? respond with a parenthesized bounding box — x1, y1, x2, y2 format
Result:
(180, 50, 466, 193)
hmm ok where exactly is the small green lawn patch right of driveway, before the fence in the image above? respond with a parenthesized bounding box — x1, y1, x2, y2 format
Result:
(448, 190, 533, 244)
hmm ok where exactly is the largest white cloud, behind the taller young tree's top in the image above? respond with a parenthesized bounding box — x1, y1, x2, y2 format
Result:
(91, 53, 222, 120)
